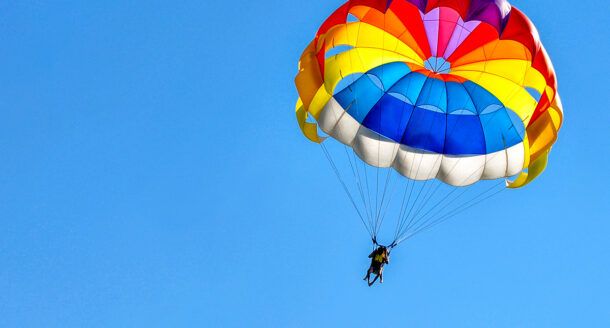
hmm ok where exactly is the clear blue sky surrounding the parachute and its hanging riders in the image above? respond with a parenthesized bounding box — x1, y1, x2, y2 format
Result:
(0, 0, 610, 328)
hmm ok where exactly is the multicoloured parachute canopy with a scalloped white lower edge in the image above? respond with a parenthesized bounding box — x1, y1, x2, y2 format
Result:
(296, 0, 563, 246)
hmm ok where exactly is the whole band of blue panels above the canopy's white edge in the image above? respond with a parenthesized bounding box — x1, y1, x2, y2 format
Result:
(334, 63, 525, 155)
